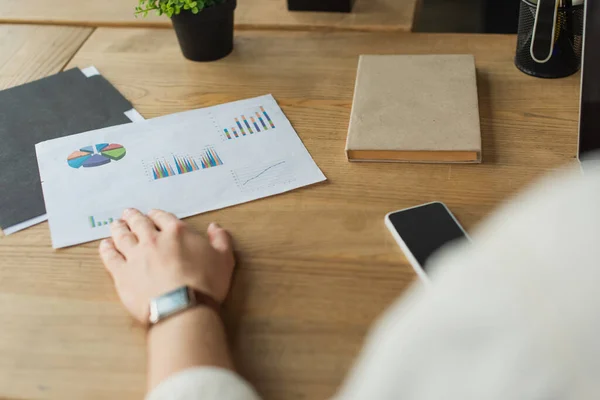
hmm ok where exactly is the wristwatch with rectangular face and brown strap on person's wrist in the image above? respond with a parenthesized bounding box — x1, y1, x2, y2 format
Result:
(150, 286, 220, 325)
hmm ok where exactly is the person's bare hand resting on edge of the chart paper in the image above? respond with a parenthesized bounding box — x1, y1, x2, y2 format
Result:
(99, 209, 235, 324)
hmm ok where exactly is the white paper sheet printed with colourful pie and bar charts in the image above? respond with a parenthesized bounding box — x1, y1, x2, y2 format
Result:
(36, 95, 326, 248)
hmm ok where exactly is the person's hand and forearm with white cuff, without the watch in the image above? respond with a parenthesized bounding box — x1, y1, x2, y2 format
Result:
(100, 209, 257, 400)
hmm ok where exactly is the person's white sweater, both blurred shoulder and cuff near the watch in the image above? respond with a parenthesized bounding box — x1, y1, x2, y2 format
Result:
(147, 162, 600, 400)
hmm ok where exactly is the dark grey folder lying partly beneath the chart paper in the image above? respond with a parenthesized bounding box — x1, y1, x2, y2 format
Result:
(0, 69, 133, 228)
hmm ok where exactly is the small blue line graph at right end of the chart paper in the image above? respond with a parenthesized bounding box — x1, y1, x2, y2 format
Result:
(231, 160, 295, 192)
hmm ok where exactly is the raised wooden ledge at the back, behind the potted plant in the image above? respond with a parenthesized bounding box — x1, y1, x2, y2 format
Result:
(0, 0, 418, 31)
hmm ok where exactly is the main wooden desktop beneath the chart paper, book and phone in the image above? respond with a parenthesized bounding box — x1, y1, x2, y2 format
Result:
(0, 29, 579, 400)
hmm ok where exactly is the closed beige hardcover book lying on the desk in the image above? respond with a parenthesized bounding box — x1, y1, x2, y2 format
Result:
(346, 55, 481, 163)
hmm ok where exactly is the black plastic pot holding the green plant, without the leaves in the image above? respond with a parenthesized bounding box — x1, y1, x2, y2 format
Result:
(171, 0, 237, 61)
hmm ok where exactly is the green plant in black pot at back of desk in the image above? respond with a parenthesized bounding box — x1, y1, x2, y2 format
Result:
(135, 0, 237, 61)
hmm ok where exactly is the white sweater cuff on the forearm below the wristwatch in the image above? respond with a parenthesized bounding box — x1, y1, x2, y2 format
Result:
(146, 367, 260, 400)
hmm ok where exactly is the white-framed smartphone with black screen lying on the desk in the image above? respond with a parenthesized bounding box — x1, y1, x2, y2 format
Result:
(385, 202, 470, 281)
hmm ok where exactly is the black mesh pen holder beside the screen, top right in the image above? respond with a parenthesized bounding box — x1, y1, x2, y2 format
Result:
(515, 0, 584, 78)
